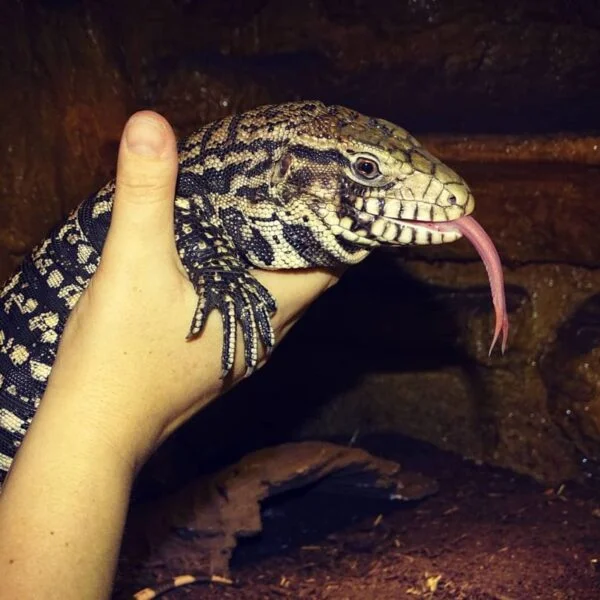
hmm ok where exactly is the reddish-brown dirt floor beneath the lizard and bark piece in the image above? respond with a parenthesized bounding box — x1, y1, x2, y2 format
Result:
(115, 437, 600, 600)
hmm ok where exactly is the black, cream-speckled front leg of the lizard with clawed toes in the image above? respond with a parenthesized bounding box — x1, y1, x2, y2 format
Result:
(175, 208, 277, 378)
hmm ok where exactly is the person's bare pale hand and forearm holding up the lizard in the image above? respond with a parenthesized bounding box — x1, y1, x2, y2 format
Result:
(0, 111, 336, 600)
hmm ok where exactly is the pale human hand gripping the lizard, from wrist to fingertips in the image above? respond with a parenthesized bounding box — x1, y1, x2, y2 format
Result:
(42, 112, 336, 467)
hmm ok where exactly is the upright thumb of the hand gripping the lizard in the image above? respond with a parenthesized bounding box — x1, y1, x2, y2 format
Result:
(102, 111, 177, 264)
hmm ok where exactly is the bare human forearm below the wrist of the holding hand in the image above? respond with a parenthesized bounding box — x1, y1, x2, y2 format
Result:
(0, 397, 134, 600)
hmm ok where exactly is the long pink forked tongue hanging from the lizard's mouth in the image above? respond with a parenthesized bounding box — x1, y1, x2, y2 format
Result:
(436, 217, 508, 354)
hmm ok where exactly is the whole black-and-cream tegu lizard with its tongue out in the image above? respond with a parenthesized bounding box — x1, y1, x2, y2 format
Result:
(0, 101, 508, 484)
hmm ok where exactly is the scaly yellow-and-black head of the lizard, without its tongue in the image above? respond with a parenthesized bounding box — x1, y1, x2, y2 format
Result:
(272, 106, 474, 261)
